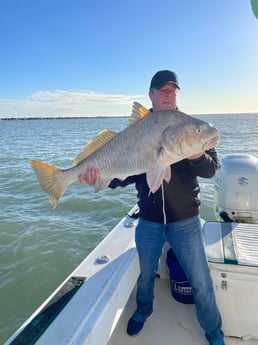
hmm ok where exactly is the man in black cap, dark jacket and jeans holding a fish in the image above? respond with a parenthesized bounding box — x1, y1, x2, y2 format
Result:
(80, 70, 224, 345)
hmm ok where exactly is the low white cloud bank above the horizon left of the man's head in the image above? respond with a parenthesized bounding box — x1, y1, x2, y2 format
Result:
(0, 90, 147, 118)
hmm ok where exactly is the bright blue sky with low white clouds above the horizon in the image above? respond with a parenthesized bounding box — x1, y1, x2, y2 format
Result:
(0, 0, 258, 118)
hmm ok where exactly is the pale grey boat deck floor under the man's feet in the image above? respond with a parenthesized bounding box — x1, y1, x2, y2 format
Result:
(108, 279, 258, 345)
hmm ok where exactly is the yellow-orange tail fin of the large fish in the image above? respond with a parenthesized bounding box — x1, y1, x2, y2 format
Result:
(30, 160, 68, 208)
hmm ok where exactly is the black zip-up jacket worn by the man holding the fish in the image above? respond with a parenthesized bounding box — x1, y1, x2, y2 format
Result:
(109, 149, 220, 223)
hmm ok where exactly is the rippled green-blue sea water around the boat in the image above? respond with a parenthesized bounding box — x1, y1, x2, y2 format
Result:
(0, 114, 258, 344)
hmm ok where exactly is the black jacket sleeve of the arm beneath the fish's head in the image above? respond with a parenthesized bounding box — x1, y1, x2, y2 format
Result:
(189, 148, 220, 178)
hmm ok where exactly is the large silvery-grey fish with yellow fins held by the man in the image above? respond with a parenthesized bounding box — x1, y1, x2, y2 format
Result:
(30, 104, 219, 207)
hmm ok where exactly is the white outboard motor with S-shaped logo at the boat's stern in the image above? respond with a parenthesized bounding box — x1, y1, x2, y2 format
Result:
(214, 154, 258, 223)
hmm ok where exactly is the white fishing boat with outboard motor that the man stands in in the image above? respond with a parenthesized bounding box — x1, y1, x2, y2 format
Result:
(5, 155, 258, 345)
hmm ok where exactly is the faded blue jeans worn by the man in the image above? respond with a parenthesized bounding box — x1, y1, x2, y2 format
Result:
(133, 216, 223, 341)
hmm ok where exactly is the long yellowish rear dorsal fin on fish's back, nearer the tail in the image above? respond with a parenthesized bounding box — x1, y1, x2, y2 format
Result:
(73, 129, 117, 164)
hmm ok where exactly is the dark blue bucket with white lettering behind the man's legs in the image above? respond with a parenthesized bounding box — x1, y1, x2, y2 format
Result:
(167, 248, 194, 304)
